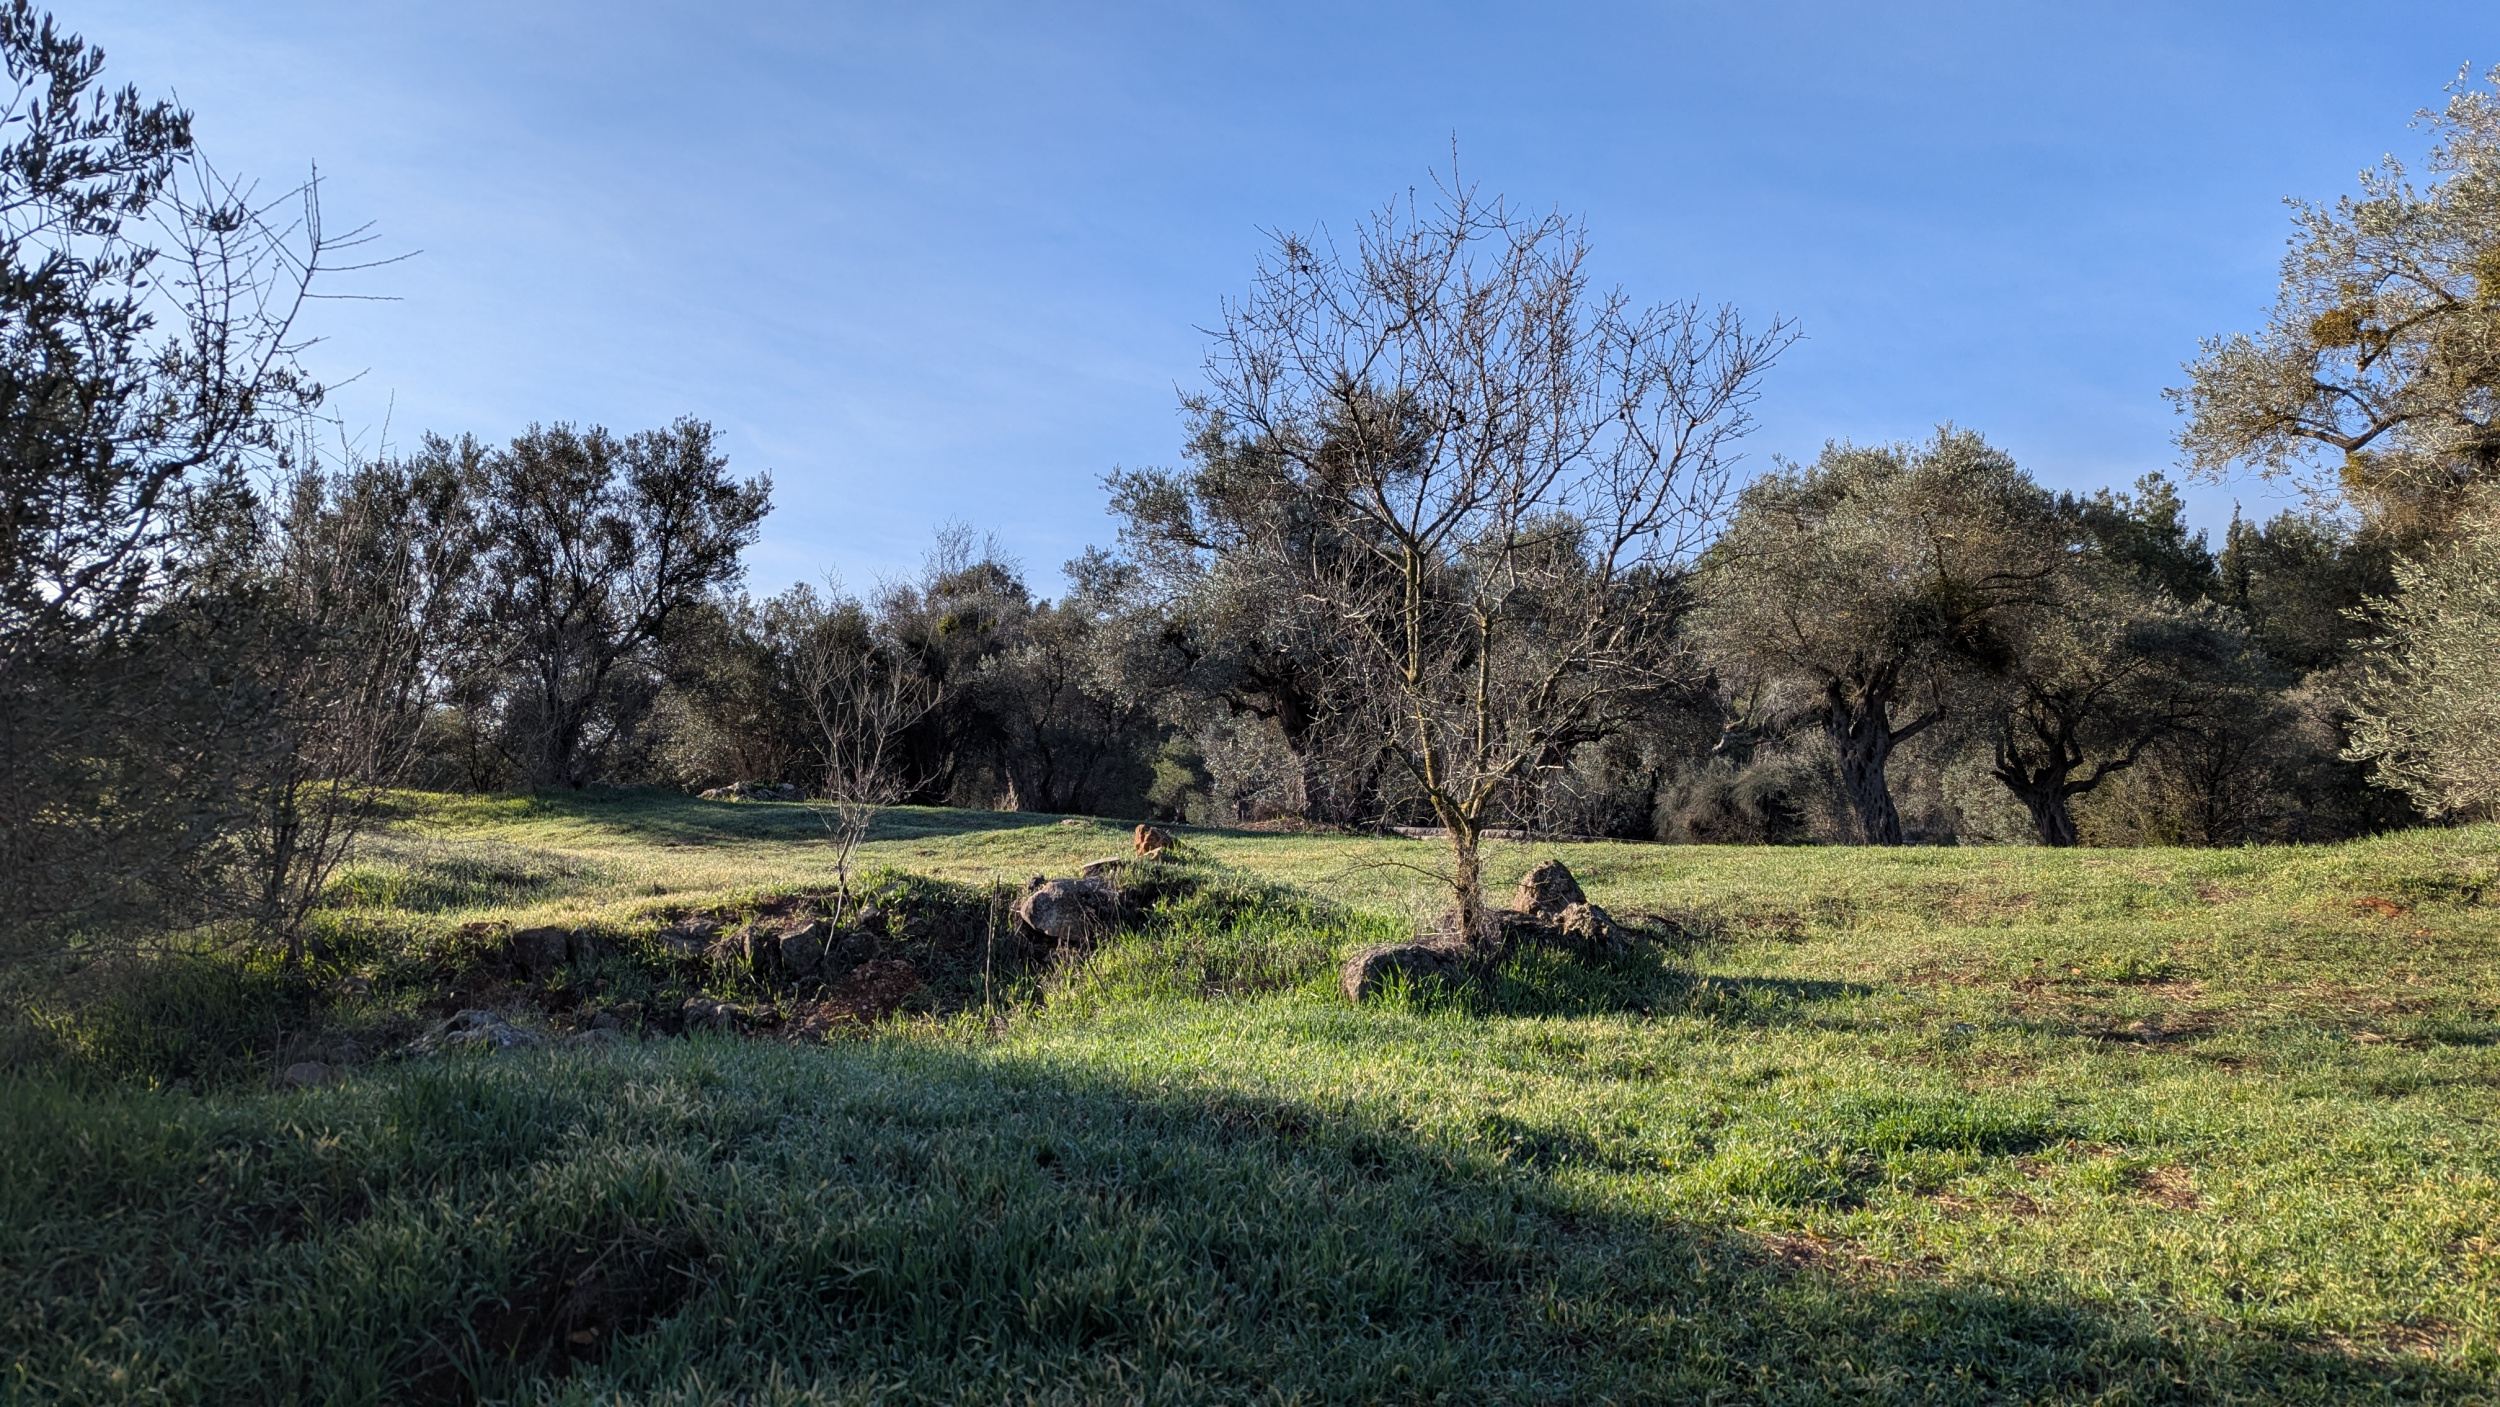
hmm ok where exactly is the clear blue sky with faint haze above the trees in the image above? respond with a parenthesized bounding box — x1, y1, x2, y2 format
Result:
(58, 0, 2500, 590)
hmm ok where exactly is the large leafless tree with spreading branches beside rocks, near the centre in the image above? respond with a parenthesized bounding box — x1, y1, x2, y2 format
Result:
(1188, 180, 1793, 962)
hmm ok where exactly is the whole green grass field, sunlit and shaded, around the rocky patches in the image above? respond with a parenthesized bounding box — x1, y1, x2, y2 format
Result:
(0, 795, 2500, 1402)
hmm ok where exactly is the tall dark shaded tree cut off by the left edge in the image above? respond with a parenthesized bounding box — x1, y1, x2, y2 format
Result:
(0, 0, 380, 954)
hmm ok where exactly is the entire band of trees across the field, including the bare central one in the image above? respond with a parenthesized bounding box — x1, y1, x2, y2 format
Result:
(0, 2, 2500, 964)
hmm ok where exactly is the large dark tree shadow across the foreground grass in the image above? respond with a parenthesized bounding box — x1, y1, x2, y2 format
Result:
(0, 1042, 2488, 1402)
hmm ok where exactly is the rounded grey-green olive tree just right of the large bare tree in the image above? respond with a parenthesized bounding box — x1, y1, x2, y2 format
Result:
(1693, 427, 2063, 845)
